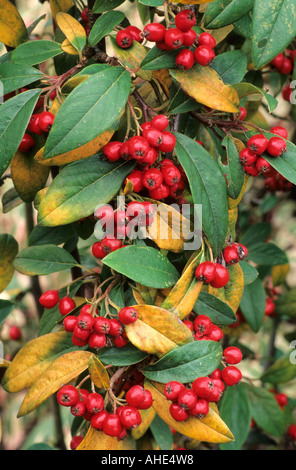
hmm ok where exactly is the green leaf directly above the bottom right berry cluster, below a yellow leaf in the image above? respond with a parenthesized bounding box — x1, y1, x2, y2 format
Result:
(143, 341, 222, 383)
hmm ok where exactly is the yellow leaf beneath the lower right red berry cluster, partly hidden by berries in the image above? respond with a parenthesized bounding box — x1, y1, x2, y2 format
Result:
(145, 381, 234, 444)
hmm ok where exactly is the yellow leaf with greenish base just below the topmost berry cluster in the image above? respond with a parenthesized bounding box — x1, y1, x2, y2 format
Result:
(170, 65, 239, 113)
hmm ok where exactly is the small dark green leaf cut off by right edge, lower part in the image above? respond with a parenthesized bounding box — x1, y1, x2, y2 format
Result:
(260, 352, 296, 385)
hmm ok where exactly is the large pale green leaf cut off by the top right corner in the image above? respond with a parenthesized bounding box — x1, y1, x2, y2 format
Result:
(252, 0, 296, 69)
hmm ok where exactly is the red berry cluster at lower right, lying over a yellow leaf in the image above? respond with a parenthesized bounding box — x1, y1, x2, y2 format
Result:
(164, 346, 242, 421)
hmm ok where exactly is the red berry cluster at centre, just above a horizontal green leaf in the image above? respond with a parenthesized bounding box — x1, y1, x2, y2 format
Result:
(92, 201, 154, 259)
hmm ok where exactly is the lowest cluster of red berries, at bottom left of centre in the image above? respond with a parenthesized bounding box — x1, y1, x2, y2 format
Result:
(57, 385, 153, 438)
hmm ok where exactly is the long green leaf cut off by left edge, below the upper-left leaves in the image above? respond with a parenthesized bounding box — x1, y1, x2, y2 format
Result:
(0, 90, 41, 176)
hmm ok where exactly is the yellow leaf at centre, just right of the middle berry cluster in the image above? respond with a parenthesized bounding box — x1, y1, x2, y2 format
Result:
(147, 200, 191, 253)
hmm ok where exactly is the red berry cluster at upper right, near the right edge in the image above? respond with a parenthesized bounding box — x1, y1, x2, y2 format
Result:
(239, 126, 288, 177)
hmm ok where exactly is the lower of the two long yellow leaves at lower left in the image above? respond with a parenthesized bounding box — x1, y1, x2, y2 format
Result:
(18, 351, 93, 417)
